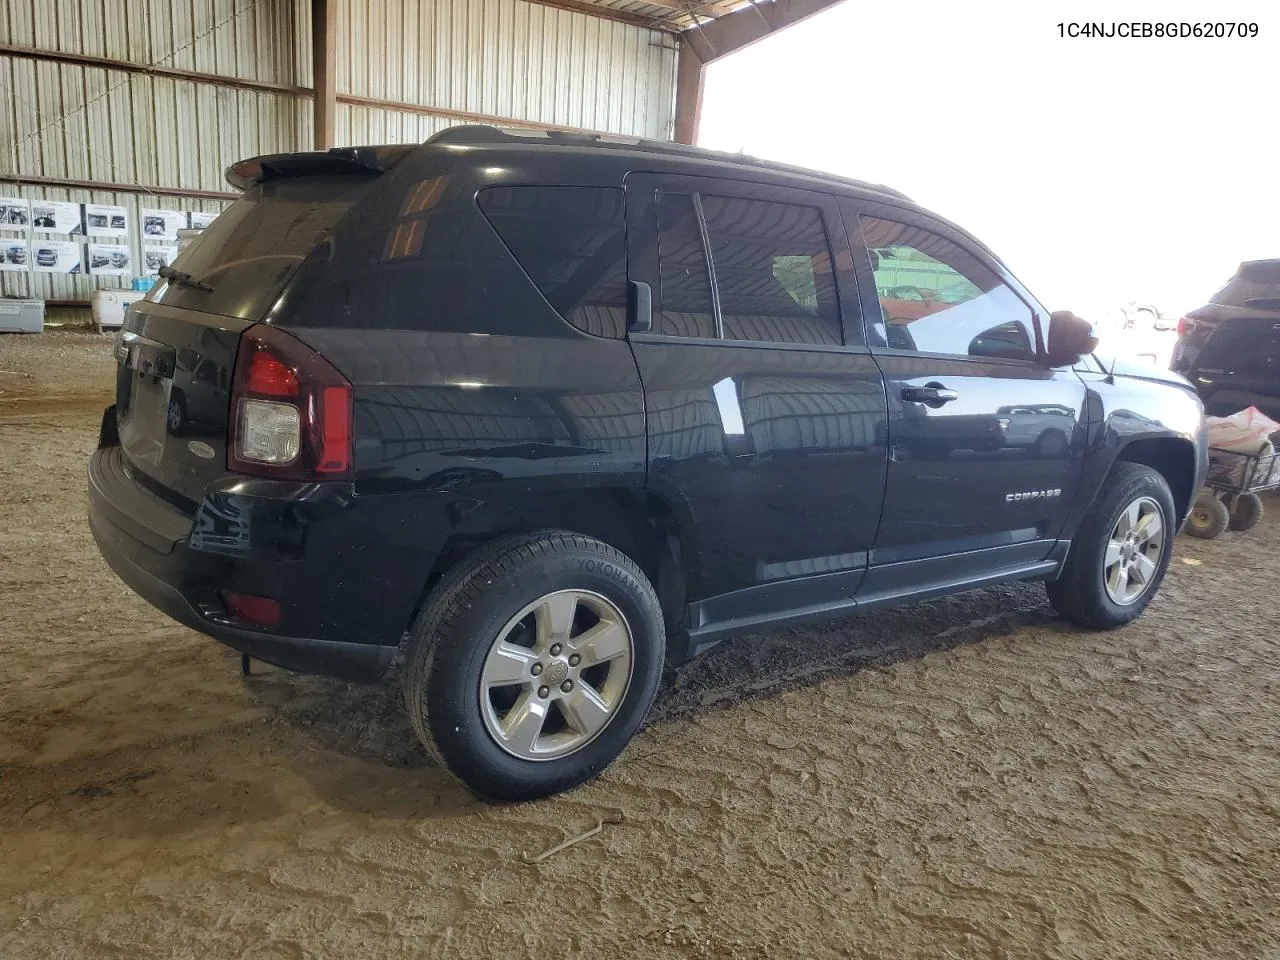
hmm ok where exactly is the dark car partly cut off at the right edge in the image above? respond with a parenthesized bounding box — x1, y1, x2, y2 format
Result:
(1170, 260, 1280, 420)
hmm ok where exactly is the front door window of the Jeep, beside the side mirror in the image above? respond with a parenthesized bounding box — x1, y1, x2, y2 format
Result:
(859, 216, 1036, 360)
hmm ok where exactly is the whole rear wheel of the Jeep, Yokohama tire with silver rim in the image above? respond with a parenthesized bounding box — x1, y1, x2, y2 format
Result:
(404, 531, 666, 800)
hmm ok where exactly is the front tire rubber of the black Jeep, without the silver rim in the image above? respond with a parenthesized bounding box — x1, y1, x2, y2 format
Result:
(1044, 463, 1175, 630)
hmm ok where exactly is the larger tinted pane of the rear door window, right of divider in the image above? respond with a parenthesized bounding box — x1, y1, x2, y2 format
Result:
(701, 196, 841, 344)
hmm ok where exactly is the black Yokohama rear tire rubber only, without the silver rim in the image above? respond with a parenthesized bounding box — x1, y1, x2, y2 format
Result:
(404, 530, 666, 801)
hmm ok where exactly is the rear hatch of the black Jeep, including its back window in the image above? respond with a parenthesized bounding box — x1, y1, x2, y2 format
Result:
(116, 151, 403, 512)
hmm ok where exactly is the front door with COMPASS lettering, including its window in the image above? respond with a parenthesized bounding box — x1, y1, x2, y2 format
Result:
(844, 202, 1085, 603)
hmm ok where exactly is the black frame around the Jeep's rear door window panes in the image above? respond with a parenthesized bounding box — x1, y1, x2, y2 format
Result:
(622, 170, 870, 355)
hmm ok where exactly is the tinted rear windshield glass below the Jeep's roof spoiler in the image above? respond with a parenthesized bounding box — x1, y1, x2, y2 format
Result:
(152, 174, 378, 320)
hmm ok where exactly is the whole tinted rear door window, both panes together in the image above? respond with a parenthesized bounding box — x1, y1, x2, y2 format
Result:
(657, 193, 842, 346)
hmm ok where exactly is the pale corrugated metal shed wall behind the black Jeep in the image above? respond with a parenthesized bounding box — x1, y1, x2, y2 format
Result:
(0, 0, 676, 300)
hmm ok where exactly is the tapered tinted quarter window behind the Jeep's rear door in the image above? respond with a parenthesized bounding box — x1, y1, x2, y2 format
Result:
(479, 187, 627, 337)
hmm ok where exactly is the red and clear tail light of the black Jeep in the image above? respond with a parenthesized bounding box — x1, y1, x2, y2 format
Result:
(227, 324, 352, 480)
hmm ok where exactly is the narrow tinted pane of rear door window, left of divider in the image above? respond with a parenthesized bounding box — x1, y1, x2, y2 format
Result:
(657, 193, 716, 338)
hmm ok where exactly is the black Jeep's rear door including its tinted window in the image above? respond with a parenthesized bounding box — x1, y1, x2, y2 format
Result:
(626, 174, 884, 640)
